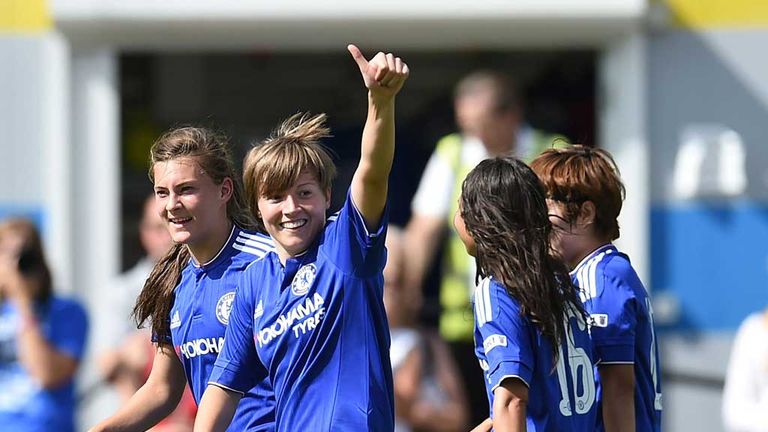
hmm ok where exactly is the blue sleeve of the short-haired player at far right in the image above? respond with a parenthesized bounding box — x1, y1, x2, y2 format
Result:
(584, 273, 638, 364)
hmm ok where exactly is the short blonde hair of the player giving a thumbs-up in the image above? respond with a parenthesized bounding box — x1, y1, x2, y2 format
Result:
(243, 113, 336, 215)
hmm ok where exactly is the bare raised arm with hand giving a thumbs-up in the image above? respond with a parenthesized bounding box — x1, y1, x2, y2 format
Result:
(347, 45, 409, 228)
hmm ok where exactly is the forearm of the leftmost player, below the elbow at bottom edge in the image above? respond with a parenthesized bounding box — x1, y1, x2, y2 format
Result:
(90, 381, 184, 432)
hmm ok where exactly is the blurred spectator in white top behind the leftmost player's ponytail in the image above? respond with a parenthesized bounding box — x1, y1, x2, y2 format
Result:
(99, 195, 197, 432)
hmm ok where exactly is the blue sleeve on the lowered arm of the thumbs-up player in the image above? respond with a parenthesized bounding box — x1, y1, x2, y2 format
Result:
(209, 261, 267, 393)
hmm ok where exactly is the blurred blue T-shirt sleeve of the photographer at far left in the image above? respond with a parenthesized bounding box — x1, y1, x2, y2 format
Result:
(50, 300, 88, 360)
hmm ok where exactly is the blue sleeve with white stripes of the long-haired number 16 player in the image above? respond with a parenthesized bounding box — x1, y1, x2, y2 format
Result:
(475, 280, 535, 391)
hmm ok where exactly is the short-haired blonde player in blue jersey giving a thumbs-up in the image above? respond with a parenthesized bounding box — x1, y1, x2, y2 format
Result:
(195, 45, 408, 432)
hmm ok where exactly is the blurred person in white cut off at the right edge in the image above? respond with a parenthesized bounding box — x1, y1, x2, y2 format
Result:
(723, 310, 768, 432)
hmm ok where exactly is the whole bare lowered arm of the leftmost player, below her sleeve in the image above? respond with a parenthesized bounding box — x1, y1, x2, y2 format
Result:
(90, 345, 186, 432)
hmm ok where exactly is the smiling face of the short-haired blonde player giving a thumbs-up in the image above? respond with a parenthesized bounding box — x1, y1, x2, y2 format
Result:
(258, 172, 331, 262)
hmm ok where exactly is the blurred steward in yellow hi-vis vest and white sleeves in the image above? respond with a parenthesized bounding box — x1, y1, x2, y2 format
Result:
(404, 71, 565, 424)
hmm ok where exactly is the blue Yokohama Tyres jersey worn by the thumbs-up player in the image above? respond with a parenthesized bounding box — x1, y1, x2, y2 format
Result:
(211, 194, 394, 432)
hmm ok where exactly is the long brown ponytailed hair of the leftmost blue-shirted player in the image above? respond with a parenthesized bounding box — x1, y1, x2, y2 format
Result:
(133, 127, 255, 343)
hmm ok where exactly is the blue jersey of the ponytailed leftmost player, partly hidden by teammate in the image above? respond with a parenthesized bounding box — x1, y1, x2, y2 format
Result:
(170, 227, 274, 431)
